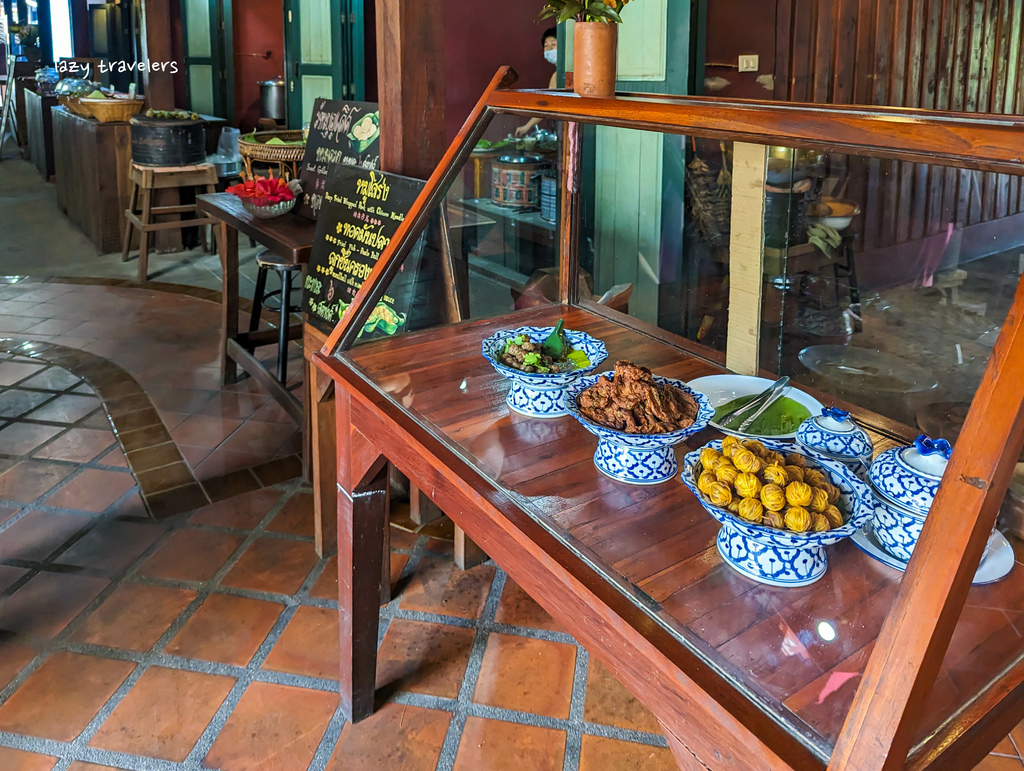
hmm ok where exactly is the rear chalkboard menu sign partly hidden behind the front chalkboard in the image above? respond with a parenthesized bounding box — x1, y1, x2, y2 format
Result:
(295, 99, 381, 219)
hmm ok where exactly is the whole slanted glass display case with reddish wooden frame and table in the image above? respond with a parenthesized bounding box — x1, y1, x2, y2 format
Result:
(316, 73, 1024, 769)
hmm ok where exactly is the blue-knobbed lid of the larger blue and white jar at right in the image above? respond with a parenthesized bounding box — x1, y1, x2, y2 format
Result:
(870, 434, 952, 514)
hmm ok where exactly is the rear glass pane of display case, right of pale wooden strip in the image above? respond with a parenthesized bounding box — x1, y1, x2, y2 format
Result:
(762, 147, 1024, 427)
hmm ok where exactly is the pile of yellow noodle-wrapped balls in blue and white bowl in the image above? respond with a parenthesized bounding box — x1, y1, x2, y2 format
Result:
(696, 436, 843, 532)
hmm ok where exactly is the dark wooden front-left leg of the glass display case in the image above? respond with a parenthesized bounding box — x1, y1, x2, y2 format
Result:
(338, 456, 389, 723)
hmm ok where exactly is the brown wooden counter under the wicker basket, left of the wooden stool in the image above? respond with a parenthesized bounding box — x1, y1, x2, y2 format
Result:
(51, 106, 131, 254)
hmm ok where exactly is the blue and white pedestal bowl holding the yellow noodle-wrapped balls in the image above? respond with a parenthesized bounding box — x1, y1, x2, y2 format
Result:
(682, 439, 872, 587)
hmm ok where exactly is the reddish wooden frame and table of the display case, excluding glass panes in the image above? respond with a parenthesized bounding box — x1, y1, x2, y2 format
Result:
(311, 72, 1024, 771)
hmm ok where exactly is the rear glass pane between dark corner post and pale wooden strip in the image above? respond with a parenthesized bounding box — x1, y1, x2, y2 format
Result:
(580, 126, 732, 352)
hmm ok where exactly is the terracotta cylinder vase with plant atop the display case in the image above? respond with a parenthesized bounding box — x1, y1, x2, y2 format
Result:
(540, 0, 630, 96)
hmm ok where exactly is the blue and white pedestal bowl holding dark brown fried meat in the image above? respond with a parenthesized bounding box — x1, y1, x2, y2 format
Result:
(564, 375, 715, 484)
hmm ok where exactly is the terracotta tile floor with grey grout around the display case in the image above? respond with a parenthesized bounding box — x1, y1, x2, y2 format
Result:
(0, 284, 1011, 771)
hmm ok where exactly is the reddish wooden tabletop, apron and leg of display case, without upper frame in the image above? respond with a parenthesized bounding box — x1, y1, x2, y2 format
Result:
(319, 306, 1024, 769)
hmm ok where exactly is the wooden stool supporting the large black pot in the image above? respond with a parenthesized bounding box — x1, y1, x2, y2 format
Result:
(121, 163, 217, 283)
